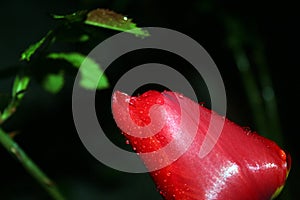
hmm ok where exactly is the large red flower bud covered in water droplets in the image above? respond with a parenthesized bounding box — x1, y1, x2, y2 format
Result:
(112, 91, 291, 200)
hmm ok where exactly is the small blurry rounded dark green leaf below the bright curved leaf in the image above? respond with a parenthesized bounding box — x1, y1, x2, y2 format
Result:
(43, 71, 64, 94)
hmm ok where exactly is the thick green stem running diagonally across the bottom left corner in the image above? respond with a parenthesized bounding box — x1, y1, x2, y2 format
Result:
(0, 128, 65, 200)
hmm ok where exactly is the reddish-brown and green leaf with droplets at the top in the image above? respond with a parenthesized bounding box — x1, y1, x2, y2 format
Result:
(85, 8, 149, 37)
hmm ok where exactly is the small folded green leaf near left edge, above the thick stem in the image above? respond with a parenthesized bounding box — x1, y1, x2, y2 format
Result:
(12, 76, 30, 99)
